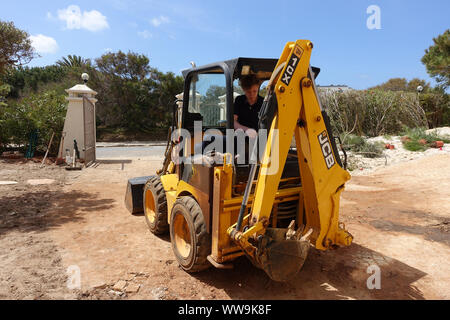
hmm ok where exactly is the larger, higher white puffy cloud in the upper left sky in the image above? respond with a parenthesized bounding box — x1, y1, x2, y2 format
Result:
(58, 5, 109, 32)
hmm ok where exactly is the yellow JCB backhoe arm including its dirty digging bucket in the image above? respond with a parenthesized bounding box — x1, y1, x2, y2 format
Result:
(228, 40, 353, 281)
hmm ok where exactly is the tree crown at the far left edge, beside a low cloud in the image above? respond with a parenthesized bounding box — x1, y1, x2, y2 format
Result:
(0, 21, 36, 74)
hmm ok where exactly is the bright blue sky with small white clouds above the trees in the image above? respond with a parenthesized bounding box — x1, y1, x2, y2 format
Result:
(0, 0, 450, 89)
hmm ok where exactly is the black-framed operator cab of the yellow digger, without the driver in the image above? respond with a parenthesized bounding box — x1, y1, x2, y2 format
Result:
(176, 58, 320, 183)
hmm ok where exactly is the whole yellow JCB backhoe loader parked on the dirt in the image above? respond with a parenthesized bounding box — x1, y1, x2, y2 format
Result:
(126, 40, 353, 281)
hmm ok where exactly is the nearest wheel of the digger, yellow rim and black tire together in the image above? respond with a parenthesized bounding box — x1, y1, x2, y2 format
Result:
(170, 197, 211, 273)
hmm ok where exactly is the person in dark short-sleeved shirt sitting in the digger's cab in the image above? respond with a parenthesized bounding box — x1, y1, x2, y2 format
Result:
(234, 74, 264, 139)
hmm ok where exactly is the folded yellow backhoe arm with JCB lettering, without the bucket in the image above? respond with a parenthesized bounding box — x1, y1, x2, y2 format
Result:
(228, 40, 353, 278)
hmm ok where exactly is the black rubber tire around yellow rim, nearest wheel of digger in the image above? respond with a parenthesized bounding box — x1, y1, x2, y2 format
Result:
(170, 197, 211, 273)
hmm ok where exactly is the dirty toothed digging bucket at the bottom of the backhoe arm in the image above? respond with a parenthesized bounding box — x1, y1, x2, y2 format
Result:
(258, 228, 310, 282)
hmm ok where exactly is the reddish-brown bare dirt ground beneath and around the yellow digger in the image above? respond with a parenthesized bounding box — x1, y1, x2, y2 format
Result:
(0, 154, 450, 300)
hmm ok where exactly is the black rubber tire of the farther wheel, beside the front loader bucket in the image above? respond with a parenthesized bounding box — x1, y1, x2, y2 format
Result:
(144, 176, 169, 235)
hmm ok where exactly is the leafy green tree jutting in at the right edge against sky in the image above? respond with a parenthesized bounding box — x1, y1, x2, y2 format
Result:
(422, 29, 450, 88)
